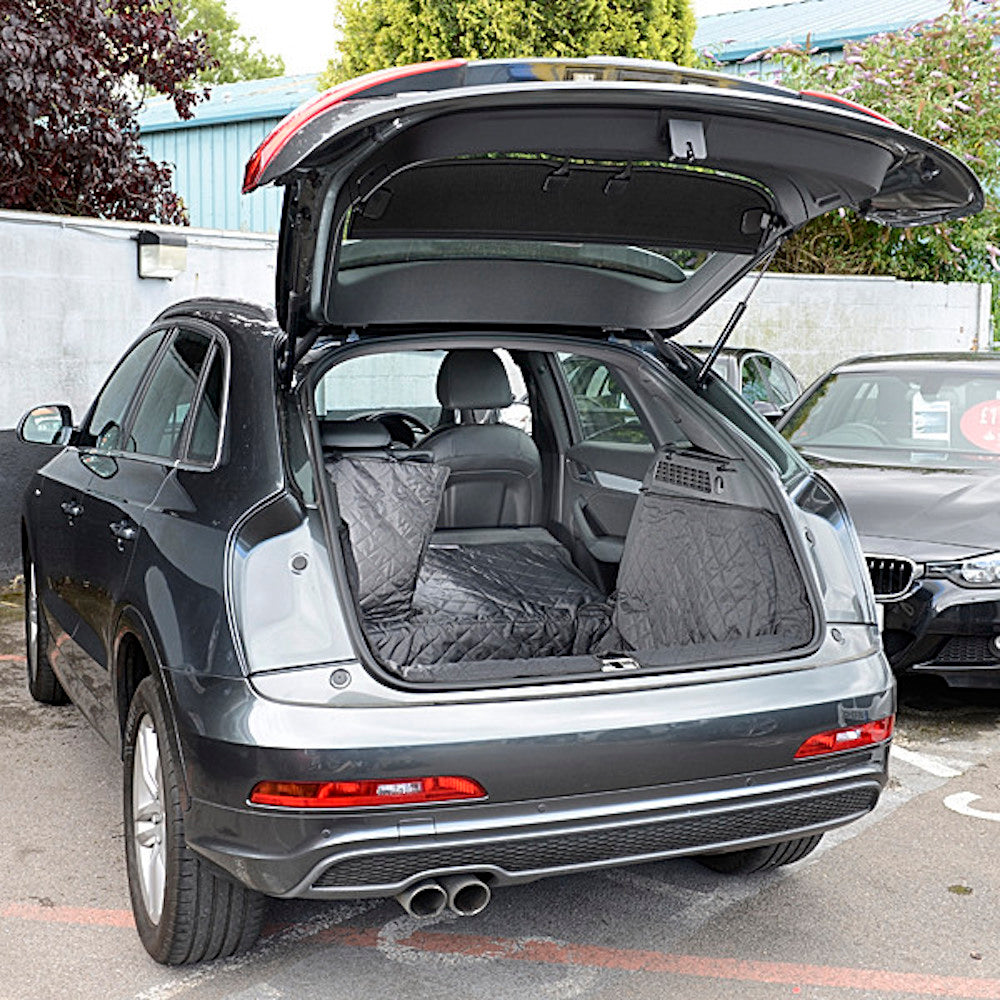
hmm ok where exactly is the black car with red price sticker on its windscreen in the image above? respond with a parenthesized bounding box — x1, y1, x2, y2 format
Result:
(780, 353, 1000, 687)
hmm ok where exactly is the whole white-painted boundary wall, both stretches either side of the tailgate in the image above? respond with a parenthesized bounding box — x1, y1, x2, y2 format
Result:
(0, 211, 990, 580)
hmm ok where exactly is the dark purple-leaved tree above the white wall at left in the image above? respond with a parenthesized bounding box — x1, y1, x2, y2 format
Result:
(0, 0, 213, 223)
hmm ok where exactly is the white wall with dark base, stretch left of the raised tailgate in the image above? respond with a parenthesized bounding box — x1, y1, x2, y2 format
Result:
(0, 211, 277, 582)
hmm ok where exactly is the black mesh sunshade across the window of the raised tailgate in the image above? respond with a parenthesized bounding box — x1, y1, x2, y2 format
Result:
(345, 152, 775, 258)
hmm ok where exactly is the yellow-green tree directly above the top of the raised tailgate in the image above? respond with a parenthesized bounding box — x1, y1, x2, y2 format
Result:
(321, 0, 695, 86)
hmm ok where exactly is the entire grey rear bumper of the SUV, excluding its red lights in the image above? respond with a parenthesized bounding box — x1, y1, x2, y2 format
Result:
(165, 644, 895, 898)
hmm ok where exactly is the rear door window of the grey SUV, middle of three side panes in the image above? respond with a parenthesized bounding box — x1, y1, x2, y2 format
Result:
(124, 330, 212, 458)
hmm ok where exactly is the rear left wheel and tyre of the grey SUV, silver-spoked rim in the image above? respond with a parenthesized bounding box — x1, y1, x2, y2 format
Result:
(124, 677, 266, 965)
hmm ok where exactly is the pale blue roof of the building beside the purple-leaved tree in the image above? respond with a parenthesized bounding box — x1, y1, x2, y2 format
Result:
(139, 73, 319, 132)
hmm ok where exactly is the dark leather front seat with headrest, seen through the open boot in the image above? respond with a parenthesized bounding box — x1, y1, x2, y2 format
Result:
(419, 348, 542, 528)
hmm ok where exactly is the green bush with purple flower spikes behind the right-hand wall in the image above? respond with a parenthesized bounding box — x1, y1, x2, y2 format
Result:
(770, 0, 1000, 315)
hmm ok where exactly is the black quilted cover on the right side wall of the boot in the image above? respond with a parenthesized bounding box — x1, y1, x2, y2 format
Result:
(613, 486, 813, 650)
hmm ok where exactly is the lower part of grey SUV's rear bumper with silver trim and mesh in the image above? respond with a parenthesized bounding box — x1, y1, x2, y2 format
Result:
(186, 744, 888, 899)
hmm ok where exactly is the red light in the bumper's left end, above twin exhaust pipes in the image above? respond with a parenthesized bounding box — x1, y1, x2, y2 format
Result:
(250, 775, 486, 809)
